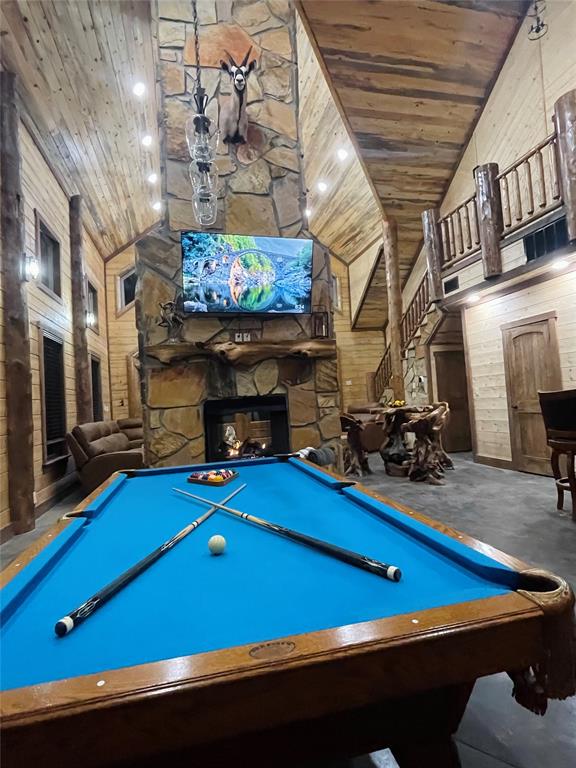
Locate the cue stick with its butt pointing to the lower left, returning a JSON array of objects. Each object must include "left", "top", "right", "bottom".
[{"left": 54, "top": 483, "right": 246, "bottom": 637}]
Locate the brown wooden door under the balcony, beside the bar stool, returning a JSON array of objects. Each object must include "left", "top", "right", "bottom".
[{"left": 502, "top": 314, "right": 562, "bottom": 475}]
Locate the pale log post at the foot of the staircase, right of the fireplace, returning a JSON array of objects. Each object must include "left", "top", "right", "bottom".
[{"left": 382, "top": 219, "right": 404, "bottom": 400}]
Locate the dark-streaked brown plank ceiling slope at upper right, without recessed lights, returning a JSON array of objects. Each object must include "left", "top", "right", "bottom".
[{"left": 299, "top": 0, "right": 527, "bottom": 327}]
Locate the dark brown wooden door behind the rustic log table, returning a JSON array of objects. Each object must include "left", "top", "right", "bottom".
[{"left": 433, "top": 349, "right": 472, "bottom": 453}]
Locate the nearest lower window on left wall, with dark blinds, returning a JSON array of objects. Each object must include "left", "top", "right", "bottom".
[{"left": 40, "top": 331, "right": 67, "bottom": 463}]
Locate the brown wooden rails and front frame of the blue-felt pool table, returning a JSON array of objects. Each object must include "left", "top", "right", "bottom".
[{"left": 0, "top": 468, "right": 573, "bottom": 768}]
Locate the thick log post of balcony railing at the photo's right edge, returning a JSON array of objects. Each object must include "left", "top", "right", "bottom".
[{"left": 554, "top": 89, "right": 576, "bottom": 240}]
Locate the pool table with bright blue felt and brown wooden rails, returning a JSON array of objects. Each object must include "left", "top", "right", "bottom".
[{"left": 1, "top": 457, "right": 574, "bottom": 768}]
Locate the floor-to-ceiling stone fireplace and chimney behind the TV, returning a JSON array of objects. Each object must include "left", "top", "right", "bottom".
[{"left": 136, "top": 0, "right": 340, "bottom": 466}]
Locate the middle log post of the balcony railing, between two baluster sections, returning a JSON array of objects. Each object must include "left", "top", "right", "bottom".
[{"left": 474, "top": 163, "right": 504, "bottom": 278}]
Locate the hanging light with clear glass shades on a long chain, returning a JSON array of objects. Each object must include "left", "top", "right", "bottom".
[{"left": 186, "top": 0, "right": 219, "bottom": 227}]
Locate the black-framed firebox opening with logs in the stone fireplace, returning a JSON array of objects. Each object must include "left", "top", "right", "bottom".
[{"left": 204, "top": 395, "right": 290, "bottom": 461}]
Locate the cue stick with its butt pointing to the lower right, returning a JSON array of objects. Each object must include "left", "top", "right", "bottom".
[{"left": 172, "top": 488, "right": 402, "bottom": 581}]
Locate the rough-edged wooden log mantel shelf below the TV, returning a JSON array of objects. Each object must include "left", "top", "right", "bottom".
[{"left": 144, "top": 339, "right": 336, "bottom": 365}]
